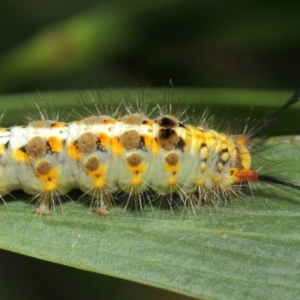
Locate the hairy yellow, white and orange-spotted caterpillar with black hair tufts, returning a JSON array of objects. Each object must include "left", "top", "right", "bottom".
[{"left": 0, "top": 92, "right": 300, "bottom": 216}]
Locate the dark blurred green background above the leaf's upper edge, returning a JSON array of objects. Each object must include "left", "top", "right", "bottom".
[{"left": 0, "top": 0, "right": 300, "bottom": 93}]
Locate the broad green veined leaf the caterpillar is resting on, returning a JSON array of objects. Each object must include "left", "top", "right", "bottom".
[{"left": 0, "top": 90, "right": 300, "bottom": 299}]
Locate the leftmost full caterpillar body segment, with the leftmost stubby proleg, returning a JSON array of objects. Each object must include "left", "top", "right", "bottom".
[{"left": 7, "top": 120, "right": 76, "bottom": 215}]
